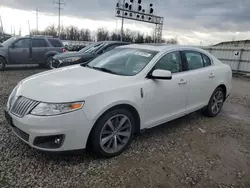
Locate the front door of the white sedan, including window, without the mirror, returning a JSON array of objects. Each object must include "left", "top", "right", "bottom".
[{"left": 143, "top": 51, "right": 189, "bottom": 127}]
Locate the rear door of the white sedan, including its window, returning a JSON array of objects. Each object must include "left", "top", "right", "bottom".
[{"left": 182, "top": 51, "right": 216, "bottom": 113}]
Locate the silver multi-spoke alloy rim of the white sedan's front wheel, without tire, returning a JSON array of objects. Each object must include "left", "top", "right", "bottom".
[{"left": 100, "top": 114, "right": 132, "bottom": 153}]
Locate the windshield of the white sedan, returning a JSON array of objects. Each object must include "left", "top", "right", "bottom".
[{"left": 85, "top": 48, "right": 157, "bottom": 76}]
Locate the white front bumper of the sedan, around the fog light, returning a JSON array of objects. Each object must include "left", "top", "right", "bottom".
[{"left": 5, "top": 110, "right": 93, "bottom": 151}]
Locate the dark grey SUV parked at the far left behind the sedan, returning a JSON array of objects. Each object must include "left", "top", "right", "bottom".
[{"left": 0, "top": 36, "right": 66, "bottom": 70}]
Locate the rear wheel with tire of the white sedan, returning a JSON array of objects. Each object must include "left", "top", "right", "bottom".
[{"left": 204, "top": 87, "right": 225, "bottom": 117}]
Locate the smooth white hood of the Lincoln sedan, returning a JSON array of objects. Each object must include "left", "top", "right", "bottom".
[{"left": 17, "top": 65, "right": 133, "bottom": 103}]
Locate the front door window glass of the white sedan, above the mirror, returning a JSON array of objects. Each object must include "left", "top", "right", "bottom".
[{"left": 154, "top": 52, "right": 182, "bottom": 73}]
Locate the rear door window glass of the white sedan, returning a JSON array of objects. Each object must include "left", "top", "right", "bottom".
[{"left": 185, "top": 52, "right": 204, "bottom": 70}]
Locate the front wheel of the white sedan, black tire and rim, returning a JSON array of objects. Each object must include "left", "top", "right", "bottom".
[{"left": 90, "top": 108, "right": 135, "bottom": 157}]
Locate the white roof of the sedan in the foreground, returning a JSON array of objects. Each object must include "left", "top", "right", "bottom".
[{"left": 118, "top": 44, "right": 206, "bottom": 52}]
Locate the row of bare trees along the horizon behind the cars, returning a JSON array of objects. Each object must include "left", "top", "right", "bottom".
[{"left": 31, "top": 25, "right": 179, "bottom": 44}]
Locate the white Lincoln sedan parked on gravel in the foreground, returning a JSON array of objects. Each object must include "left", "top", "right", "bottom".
[{"left": 6, "top": 45, "right": 232, "bottom": 157}]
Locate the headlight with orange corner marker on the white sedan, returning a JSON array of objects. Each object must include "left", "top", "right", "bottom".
[{"left": 31, "top": 102, "right": 84, "bottom": 116}]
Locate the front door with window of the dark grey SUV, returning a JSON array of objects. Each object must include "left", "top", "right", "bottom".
[{"left": 9, "top": 38, "right": 31, "bottom": 64}]
